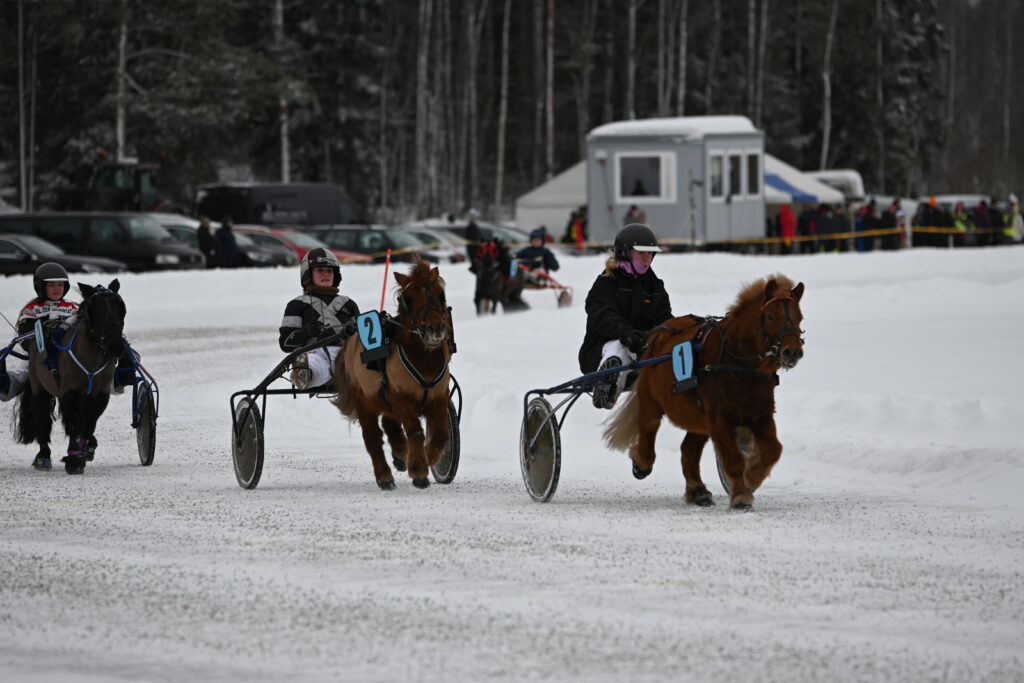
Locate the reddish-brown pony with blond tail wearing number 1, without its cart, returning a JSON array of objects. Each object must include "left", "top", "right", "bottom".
[{"left": 604, "top": 275, "right": 804, "bottom": 508}]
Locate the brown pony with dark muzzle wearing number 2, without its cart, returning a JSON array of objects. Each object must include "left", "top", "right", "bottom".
[{"left": 334, "top": 256, "right": 454, "bottom": 490}]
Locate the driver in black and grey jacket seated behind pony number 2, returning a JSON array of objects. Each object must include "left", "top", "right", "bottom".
[{"left": 279, "top": 247, "right": 359, "bottom": 389}]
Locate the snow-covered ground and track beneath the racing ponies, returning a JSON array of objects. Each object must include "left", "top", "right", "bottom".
[{"left": 0, "top": 248, "right": 1024, "bottom": 682}]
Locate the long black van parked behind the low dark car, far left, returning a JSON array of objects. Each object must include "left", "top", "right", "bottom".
[{"left": 0, "top": 211, "right": 206, "bottom": 270}]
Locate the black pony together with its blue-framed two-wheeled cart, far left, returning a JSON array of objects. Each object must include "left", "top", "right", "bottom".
[{"left": 0, "top": 281, "right": 160, "bottom": 474}]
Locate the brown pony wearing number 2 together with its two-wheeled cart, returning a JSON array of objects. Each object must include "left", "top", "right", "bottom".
[{"left": 230, "top": 262, "right": 462, "bottom": 489}]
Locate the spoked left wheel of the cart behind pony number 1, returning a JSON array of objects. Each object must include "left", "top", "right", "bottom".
[{"left": 519, "top": 396, "right": 562, "bottom": 503}]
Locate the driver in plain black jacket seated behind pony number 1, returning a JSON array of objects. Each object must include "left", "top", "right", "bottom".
[{"left": 580, "top": 223, "right": 673, "bottom": 409}]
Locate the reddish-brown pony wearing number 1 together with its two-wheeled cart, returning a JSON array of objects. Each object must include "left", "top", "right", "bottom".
[{"left": 519, "top": 275, "right": 804, "bottom": 509}]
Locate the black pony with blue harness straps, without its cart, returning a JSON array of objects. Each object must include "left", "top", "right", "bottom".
[{"left": 16, "top": 280, "right": 126, "bottom": 474}]
